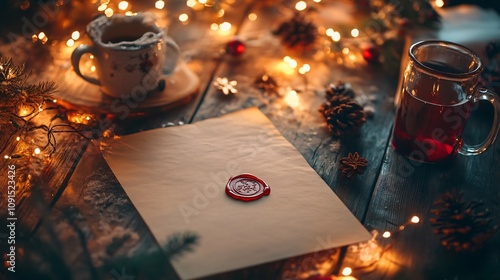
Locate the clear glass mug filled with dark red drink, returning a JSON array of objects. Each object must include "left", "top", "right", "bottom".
[{"left": 391, "top": 41, "right": 500, "bottom": 162}]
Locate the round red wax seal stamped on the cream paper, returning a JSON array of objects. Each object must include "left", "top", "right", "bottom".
[{"left": 226, "top": 173, "right": 271, "bottom": 201}]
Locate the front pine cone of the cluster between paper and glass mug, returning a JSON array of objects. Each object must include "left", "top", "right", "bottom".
[{"left": 323, "top": 102, "right": 366, "bottom": 137}]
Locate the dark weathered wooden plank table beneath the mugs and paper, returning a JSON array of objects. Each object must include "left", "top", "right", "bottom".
[{"left": 0, "top": 1, "right": 500, "bottom": 279}]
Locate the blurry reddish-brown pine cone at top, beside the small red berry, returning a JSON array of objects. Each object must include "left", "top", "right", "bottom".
[{"left": 273, "top": 14, "right": 318, "bottom": 48}]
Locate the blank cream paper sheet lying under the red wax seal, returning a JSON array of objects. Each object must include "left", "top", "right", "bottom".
[{"left": 104, "top": 108, "right": 370, "bottom": 279}]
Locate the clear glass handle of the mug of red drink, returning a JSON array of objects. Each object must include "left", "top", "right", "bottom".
[{"left": 458, "top": 88, "right": 500, "bottom": 156}]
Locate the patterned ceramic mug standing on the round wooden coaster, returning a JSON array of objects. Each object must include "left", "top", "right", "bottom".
[{"left": 71, "top": 13, "right": 179, "bottom": 98}]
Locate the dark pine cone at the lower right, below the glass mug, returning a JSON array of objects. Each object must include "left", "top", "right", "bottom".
[{"left": 430, "top": 190, "right": 498, "bottom": 252}]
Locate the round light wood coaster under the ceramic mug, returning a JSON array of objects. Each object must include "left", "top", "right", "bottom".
[{"left": 55, "top": 61, "right": 200, "bottom": 117}]
